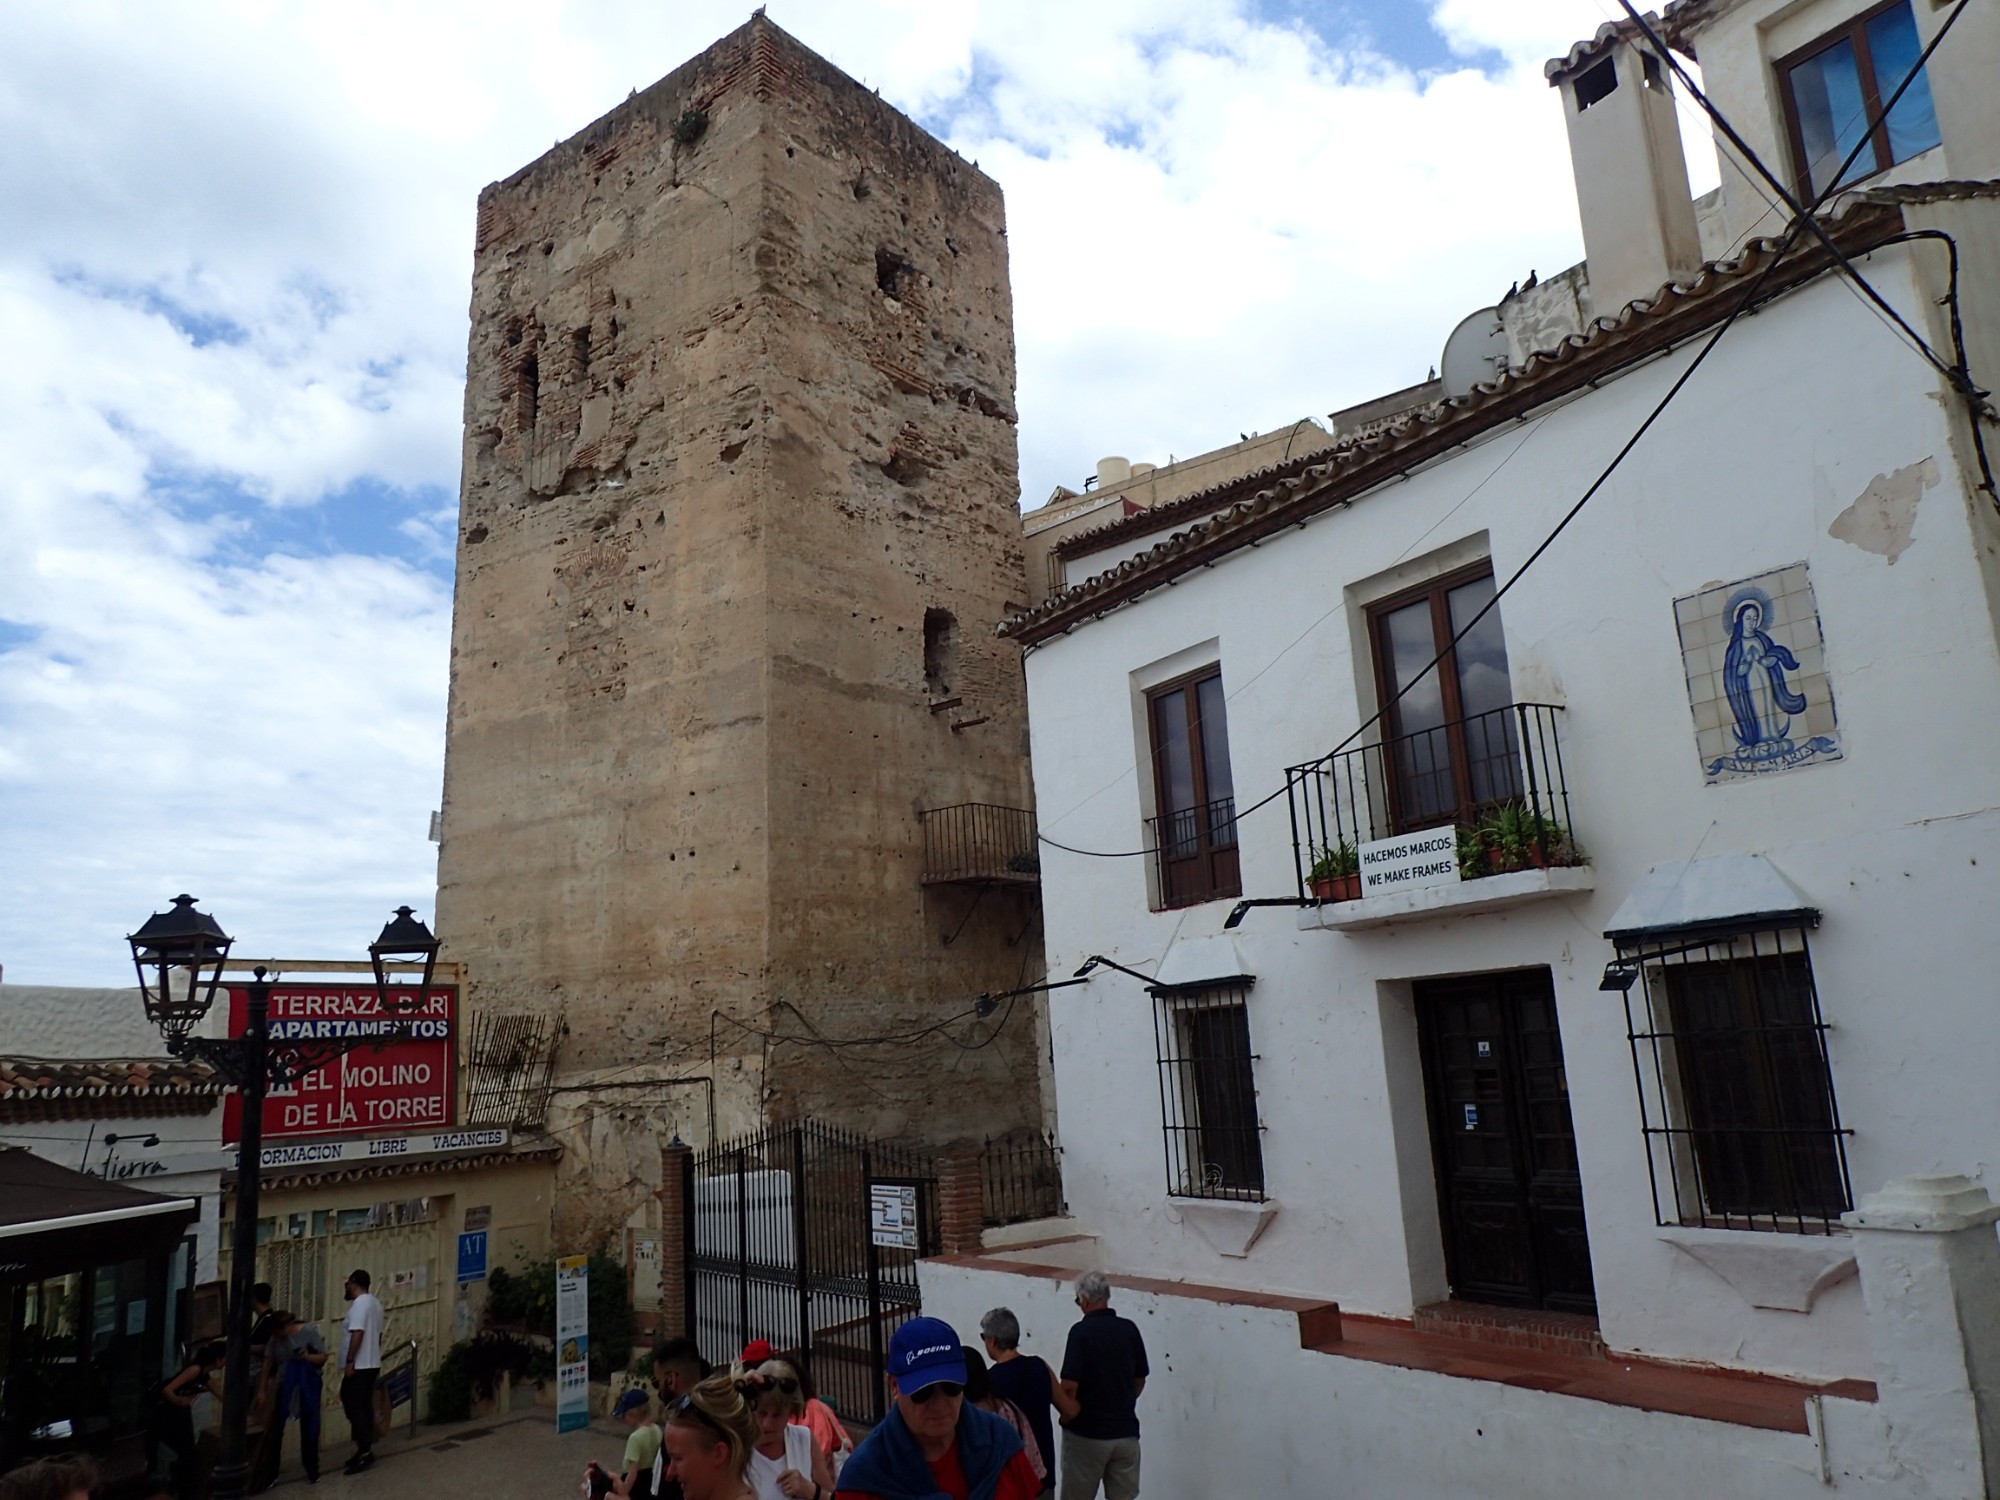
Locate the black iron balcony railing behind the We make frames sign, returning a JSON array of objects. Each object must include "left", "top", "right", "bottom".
[{"left": 1284, "top": 704, "right": 1580, "bottom": 898}]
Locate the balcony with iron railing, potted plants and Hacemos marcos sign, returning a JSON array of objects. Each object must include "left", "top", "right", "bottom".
[{"left": 1286, "top": 704, "right": 1592, "bottom": 928}]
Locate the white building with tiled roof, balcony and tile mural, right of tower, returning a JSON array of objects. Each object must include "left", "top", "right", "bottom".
[{"left": 924, "top": 0, "right": 2000, "bottom": 1496}]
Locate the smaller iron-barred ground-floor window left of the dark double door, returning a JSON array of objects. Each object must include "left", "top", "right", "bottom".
[{"left": 1152, "top": 980, "right": 1264, "bottom": 1200}]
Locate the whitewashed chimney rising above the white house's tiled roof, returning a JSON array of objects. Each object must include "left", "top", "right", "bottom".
[{"left": 1544, "top": 16, "right": 1702, "bottom": 318}]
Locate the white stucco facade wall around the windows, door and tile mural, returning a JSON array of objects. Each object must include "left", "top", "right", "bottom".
[{"left": 1026, "top": 238, "right": 2000, "bottom": 1400}]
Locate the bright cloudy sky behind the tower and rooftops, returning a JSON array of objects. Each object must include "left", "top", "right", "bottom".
[{"left": 0, "top": 0, "right": 1720, "bottom": 982}]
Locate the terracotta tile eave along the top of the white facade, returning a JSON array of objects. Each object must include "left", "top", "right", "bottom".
[{"left": 998, "top": 182, "right": 2000, "bottom": 644}]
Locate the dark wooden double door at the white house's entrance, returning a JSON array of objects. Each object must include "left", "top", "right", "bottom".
[{"left": 1416, "top": 968, "right": 1596, "bottom": 1312}]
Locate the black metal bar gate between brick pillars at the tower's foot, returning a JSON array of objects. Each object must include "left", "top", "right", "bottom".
[{"left": 684, "top": 1120, "right": 938, "bottom": 1422}]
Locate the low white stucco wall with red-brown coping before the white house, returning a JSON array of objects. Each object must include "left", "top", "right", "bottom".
[{"left": 920, "top": 1262, "right": 1886, "bottom": 1500}]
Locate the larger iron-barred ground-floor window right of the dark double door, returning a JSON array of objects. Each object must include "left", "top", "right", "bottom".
[{"left": 1606, "top": 912, "right": 1854, "bottom": 1234}]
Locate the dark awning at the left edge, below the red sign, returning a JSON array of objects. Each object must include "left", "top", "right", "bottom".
[{"left": 0, "top": 1146, "right": 200, "bottom": 1282}]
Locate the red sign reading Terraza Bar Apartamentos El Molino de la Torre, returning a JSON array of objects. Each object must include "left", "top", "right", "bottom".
[{"left": 222, "top": 984, "right": 458, "bottom": 1146}]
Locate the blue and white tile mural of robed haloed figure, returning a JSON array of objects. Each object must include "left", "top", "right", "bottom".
[{"left": 1674, "top": 562, "right": 1840, "bottom": 782}]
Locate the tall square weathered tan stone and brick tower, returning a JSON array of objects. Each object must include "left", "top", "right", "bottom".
[{"left": 438, "top": 12, "right": 1044, "bottom": 1228}]
